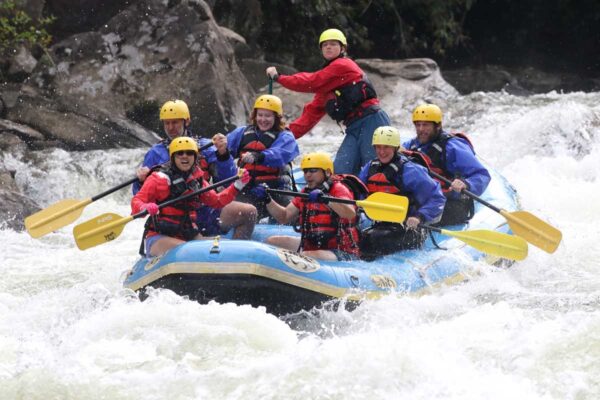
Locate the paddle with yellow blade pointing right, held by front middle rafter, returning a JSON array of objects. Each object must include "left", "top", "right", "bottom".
[{"left": 267, "top": 189, "right": 408, "bottom": 223}]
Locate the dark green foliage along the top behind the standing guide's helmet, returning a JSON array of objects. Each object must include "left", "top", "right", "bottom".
[{"left": 213, "top": 0, "right": 476, "bottom": 69}]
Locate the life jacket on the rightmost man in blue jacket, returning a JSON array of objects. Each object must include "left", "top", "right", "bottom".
[{"left": 402, "top": 131, "right": 475, "bottom": 193}]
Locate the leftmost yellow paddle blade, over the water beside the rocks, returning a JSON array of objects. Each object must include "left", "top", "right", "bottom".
[{"left": 25, "top": 198, "right": 92, "bottom": 238}]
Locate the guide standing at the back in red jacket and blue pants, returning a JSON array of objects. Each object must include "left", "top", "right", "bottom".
[{"left": 266, "top": 29, "right": 390, "bottom": 174}]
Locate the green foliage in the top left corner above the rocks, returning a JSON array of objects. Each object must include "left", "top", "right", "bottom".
[{"left": 0, "top": 0, "right": 55, "bottom": 54}]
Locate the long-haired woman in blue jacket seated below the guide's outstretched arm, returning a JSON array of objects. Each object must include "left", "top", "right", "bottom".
[{"left": 226, "top": 94, "right": 300, "bottom": 220}]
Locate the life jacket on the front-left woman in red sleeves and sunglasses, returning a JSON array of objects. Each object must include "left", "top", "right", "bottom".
[{"left": 145, "top": 166, "right": 204, "bottom": 240}]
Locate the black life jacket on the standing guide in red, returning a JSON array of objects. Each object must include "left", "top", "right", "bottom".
[{"left": 325, "top": 75, "right": 379, "bottom": 125}]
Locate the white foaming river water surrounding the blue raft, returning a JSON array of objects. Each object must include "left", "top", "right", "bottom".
[{"left": 0, "top": 89, "right": 600, "bottom": 400}]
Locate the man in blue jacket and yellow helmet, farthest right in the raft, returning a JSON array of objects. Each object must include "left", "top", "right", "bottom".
[{"left": 404, "top": 104, "right": 491, "bottom": 225}]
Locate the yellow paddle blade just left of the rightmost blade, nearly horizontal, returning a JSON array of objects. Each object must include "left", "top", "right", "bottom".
[{"left": 441, "top": 229, "right": 528, "bottom": 260}]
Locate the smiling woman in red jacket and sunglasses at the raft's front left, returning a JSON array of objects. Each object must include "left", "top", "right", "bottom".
[{"left": 131, "top": 137, "right": 256, "bottom": 256}]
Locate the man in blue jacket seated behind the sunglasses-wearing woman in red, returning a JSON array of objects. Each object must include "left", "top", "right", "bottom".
[{"left": 132, "top": 100, "right": 256, "bottom": 239}]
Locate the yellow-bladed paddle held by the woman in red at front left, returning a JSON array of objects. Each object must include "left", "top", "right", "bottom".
[{"left": 73, "top": 175, "right": 239, "bottom": 250}]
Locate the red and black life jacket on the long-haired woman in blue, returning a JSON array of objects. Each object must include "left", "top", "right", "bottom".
[{"left": 238, "top": 125, "right": 281, "bottom": 183}]
